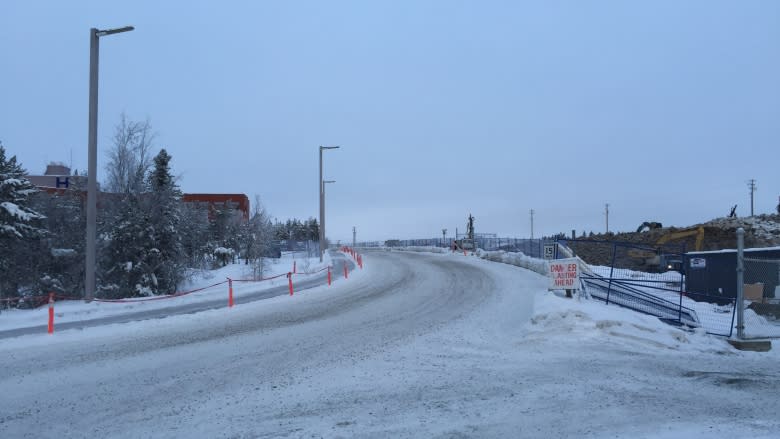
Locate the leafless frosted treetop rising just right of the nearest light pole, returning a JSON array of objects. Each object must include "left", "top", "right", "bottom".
[{"left": 106, "top": 113, "right": 155, "bottom": 194}]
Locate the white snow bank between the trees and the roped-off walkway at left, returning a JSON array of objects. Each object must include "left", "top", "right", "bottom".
[{"left": 0, "top": 253, "right": 332, "bottom": 331}]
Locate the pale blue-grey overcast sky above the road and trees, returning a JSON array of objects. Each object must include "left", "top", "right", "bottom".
[{"left": 0, "top": 0, "right": 780, "bottom": 240}]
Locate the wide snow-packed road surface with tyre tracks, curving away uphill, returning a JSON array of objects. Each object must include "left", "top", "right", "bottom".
[{"left": 0, "top": 253, "right": 780, "bottom": 438}]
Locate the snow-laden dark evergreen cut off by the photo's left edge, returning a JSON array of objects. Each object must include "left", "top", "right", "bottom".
[{"left": 0, "top": 143, "right": 44, "bottom": 295}]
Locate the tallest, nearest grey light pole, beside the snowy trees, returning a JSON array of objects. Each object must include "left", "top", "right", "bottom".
[{"left": 84, "top": 26, "right": 135, "bottom": 301}]
